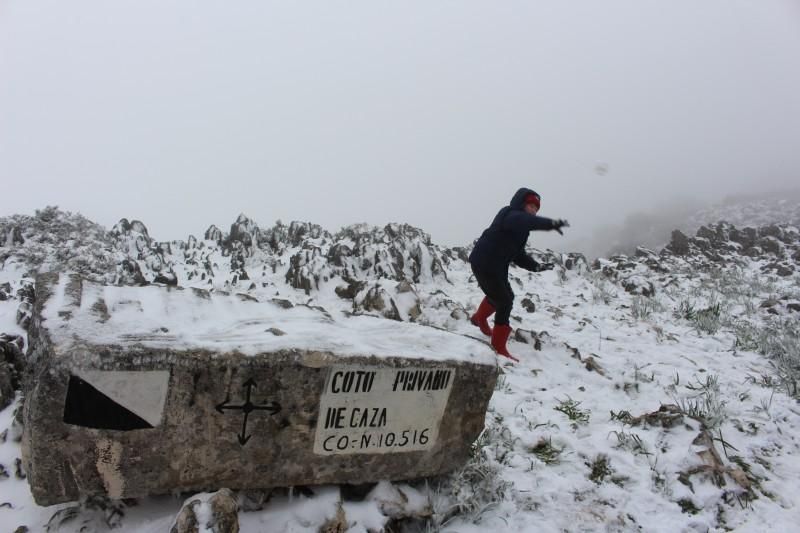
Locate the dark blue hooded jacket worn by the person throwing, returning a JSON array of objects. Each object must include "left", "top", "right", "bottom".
[{"left": 469, "top": 187, "right": 554, "bottom": 276}]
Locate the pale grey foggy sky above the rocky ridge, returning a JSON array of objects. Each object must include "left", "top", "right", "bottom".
[{"left": 0, "top": 0, "right": 800, "bottom": 249}]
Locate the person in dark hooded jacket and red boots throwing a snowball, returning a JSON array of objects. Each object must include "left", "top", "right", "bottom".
[{"left": 469, "top": 187, "right": 569, "bottom": 361}]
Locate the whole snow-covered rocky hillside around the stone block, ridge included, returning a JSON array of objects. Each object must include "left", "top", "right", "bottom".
[{"left": 0, "top": 208, "right": 800, "bottom": 532}]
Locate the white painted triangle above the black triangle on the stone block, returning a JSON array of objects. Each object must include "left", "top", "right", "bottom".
[{"left": 76, "top": 370, "right": 169, "bottom": 427}]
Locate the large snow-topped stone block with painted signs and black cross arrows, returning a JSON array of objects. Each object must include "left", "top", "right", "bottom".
[{"left": 23, "top": 274, "right": 498, "bottom": 505}]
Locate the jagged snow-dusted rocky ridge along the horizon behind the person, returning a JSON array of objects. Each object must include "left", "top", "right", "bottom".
[{"left": 0, "top": 207, "right": 800, "bottom": 325}]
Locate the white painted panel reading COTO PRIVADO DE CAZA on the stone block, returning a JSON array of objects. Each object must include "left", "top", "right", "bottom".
[{"left": 314, "top": 366, "right": 456, "bottom": 455}]
